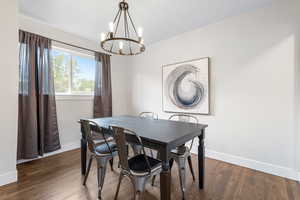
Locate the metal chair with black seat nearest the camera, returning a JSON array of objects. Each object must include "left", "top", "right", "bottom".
[{"left": 112, "top": 127, "right": 162, "bottom": 200}]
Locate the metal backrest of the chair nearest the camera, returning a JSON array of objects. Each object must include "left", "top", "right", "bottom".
[{"left": 111, "top": 126, "right": 151, "bottom": 173}]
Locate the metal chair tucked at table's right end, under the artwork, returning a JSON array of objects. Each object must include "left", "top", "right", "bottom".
[{"left": 152, "top": 114, "right": 199, "bottom": 199}]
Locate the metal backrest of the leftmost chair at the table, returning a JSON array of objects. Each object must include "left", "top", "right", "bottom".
[{"left": 80, "top": 119, "right": 113, "bottom": 155}]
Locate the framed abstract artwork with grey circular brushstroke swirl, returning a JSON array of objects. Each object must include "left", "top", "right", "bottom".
[{"left": 162, "top": 57, "right": 210, "bottom": 115}]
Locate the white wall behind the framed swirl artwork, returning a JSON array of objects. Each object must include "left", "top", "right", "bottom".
[{"left": 120, "top": 0, "right": 300, "bottom": 178}]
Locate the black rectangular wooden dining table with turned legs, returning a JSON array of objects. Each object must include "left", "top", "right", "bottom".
[{"left": 81, "top": 115, "right": 208, "bottom": 200}]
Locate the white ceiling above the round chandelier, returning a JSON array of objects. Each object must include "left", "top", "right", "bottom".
[{"left": 19, "top": 0, "right": 272, "bottom": 44}]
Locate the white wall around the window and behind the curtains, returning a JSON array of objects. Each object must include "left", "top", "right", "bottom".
[{"left": 19, "top": 15, "right": 128, "bottom": 155}]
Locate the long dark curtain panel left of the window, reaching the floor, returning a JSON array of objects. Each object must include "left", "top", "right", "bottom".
[{"left": 18, "top": 31, "right": 60, "bottom": 159}]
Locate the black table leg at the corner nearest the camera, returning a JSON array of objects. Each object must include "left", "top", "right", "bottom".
[{"left": 160, "top": 147, "right": 171, "bottom": 200}]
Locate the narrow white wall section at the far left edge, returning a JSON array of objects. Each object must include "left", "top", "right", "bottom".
[{"left": 0, "top": 0, "right": 19, "bottom": 186}]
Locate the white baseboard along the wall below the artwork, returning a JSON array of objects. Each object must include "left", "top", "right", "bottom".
[{"left": 192, "top": 148, "right": 300, "bottom": 181}]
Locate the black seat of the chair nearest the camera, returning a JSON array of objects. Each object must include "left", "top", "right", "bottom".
[{"left": 128, "top": 154, "right": 161, "bottom": 176}]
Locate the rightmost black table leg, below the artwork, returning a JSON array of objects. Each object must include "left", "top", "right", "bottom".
[{"left": 198, "top": 130, "right": 205, "bottom": 189}]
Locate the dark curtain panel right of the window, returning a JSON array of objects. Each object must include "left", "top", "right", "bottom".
[{"left": 94, "top": 53, "right": 112, "bottom": 118}]
